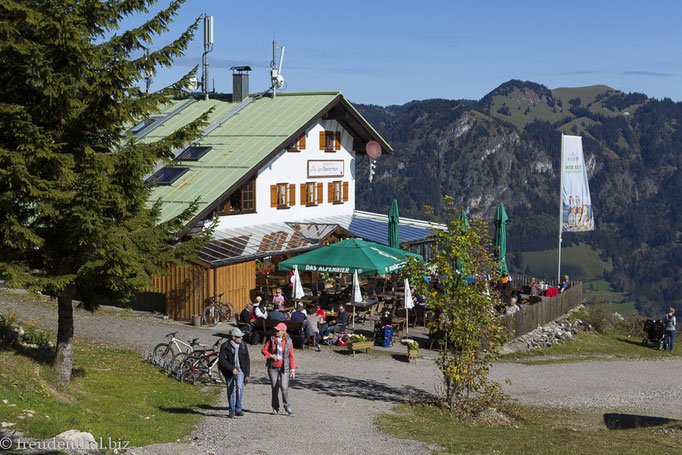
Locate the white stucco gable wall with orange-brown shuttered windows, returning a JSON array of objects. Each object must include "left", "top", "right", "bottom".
[{"left": 218, "top": 120, "right": 355, "bottom": 229}]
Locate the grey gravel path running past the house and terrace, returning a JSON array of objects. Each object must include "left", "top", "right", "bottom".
[{"left": 0, "top": 292, "right": 682, "bottom": 455}]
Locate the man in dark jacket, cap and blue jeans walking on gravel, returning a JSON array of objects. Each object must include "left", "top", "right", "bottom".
[{"left": 218, "top": 329, "right": 251, "bottom": 418}]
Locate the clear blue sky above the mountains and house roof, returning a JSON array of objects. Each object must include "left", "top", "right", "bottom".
[{"left": 127, "top": 0, "right": 682, "bottom": 105}]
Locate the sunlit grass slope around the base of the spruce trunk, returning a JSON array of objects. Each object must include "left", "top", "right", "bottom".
[{"left": 0, "top": 341, "right": 220, "bottom": 446}]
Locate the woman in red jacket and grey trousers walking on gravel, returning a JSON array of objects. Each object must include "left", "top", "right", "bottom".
[{"left": 261, "top": 322, "right": 297, "bottom": 415}]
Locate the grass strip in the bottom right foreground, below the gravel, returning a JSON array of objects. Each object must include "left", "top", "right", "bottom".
[{"left": 377, "top": 405, "right": 682, "bottom": 455}]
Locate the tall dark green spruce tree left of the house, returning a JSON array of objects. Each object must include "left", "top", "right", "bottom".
[{"left": 0, "top": 0, "right": 211, "bottom": 386}]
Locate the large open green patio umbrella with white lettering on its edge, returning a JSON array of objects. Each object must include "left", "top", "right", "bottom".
[{"left": 277, "top": 239, "right": 423, "bottom": 275}]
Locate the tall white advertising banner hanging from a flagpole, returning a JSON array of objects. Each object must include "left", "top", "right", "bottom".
[{"left": 561, "top": 135, "right": 594, "bottom": 232}]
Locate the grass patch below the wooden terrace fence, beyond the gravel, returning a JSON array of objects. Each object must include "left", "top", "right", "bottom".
[{"left": 502, "top": 329, "right": 681, "bottom": 364}]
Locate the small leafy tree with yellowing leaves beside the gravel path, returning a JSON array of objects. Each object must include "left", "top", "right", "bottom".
[{"left": 404, "top": 197, "right": 506, "bottom": 414}]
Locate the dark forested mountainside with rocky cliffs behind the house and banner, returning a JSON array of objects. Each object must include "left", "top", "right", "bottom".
[{"left": 356, "top": 81, "right": 682, "bottom": 314}]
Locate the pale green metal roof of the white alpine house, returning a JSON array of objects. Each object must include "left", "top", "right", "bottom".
[{"left": 142, "top": 92, "right": 390, "bottom": 226}]
